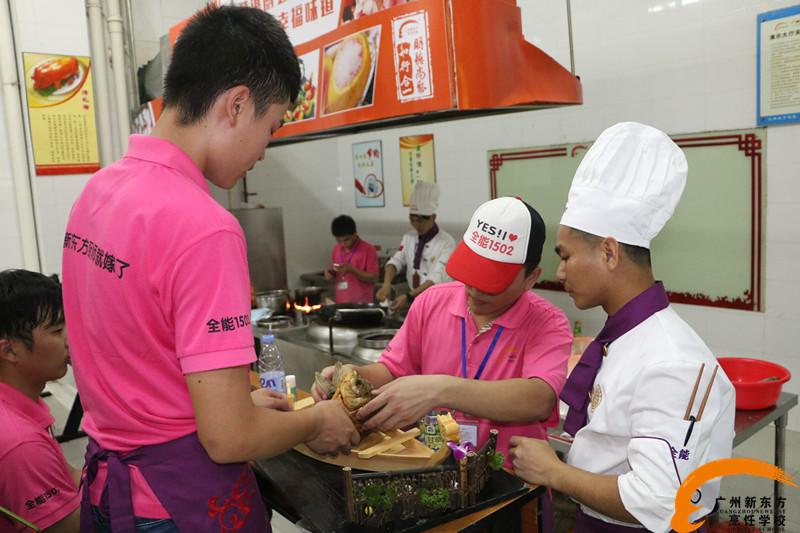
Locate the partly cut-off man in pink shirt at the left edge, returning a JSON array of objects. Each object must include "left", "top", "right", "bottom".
[{"left": 0, "top": 270, "right": 80, "bottom": 533}]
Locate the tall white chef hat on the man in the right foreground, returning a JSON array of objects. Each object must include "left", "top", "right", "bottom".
[{"left": 561, "top": 122, "right": 689, "bottom": 248}]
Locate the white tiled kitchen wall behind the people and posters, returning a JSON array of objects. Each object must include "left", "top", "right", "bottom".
[{"left": 0, "top": 0, "right": 800, "bottom": 429}]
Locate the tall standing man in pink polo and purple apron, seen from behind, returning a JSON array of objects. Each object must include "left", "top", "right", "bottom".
[{"left": 63, "top": 5, "right": 359, "bottom": 533}]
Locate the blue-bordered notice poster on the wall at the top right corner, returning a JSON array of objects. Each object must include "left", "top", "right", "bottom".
[{"left": 756, "top": 6, "right": 800, "bottom": 126}]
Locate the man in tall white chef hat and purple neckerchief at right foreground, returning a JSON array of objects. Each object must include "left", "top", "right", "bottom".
[{"left": 510, "top": 122, "right": 735, "bottom": 533}]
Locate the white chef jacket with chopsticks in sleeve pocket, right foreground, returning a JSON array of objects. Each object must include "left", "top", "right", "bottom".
[{"left": 567, "top": 307, "right": 735, "bottom": 533}]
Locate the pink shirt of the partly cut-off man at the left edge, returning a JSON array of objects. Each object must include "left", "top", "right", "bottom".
[{"left": 0, "top": 382, "right": 80, "bottom": 533}]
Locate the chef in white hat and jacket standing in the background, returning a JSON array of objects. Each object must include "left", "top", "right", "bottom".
[{"left": 375, "top": 181, "right": 456, "bottom": 309}]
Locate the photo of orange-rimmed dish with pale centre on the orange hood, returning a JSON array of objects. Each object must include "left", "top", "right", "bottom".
[{"left": 322, "top": 26, "right": 381, "bottom": 115}]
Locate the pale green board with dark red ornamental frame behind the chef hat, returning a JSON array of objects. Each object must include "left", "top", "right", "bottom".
[{"left": 488, "top": 128, "right": 767, "bottom": 311}]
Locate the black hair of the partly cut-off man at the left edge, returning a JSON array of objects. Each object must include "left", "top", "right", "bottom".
[{"left": 0, "top": 269, "right": 64, "bottom": 350}]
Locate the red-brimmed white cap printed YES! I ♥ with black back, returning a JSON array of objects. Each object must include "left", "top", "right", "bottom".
[{"left": 447, "top": 196, "right": 545, "bottom": 294}]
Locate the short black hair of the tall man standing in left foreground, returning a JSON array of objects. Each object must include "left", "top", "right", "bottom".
[{"left": 163, "top": 5, "right": 301, "bottom": 126}]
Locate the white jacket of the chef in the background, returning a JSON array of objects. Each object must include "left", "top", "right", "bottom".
[{"left": 386, "top": 228, "right": 456, "bottom": 289}]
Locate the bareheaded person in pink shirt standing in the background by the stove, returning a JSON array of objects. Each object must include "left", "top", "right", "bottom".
[{"left": 325, "top": 215, "right": 380, "bottom": 304}]
